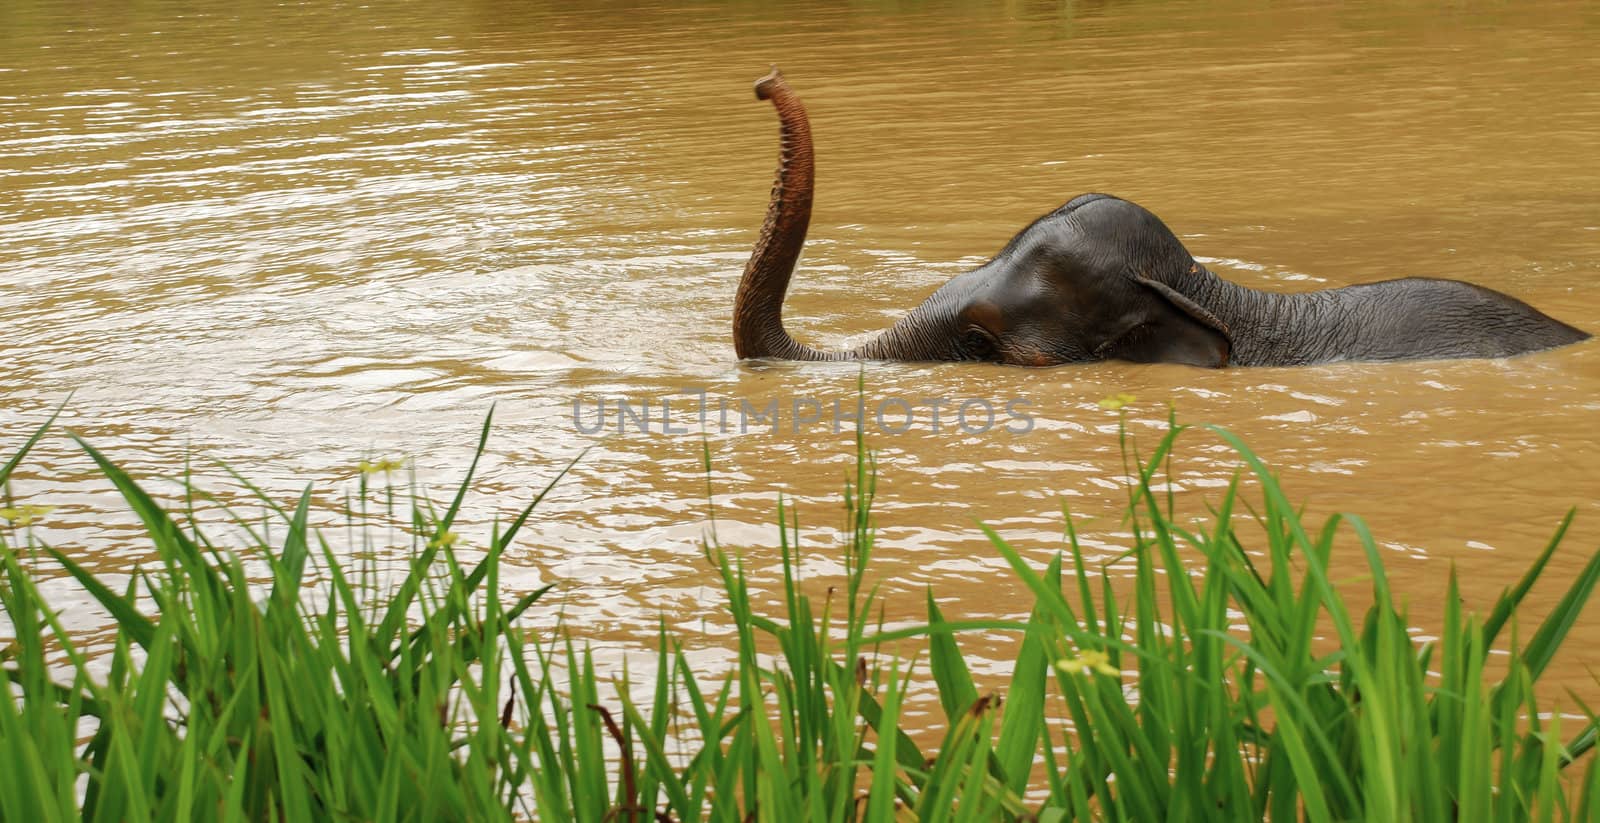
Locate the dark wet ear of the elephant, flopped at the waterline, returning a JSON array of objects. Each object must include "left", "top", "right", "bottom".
[{"left": 1099, "top": 274, "right": 1234, "bottom": 368}]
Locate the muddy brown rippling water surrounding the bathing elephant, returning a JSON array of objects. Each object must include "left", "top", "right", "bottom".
[{"left": 0, "top": 0, "right": 1600, "bottom": 703}]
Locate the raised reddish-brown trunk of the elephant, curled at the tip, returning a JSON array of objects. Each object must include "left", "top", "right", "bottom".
[{"left": 733, "top": 67, "right": 843, "bottom": 360}]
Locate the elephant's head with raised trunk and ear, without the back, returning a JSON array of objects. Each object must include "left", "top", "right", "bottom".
[{"left": 733, "top": 69, "right": 1232, "bottom": 367}]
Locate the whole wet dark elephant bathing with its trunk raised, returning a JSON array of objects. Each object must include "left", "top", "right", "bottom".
[{"left": 733, "top": 67, "right": 1589, "bottom": 368}]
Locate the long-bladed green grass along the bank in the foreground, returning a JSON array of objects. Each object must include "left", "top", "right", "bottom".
[{"left": 0, "top": 400, "right": 1600, "bottom": 823}]
